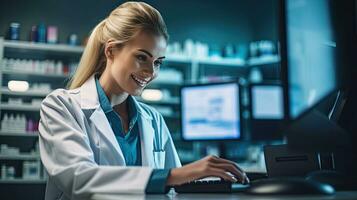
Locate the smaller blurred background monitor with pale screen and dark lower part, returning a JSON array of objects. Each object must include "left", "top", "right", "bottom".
[{"left": 246, "top": 82, "right": 284, "bottom": 142}]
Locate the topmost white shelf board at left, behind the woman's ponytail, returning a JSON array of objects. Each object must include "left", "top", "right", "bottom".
[{"left": 4, "top": 40, "right": 84, "bottom": 54}]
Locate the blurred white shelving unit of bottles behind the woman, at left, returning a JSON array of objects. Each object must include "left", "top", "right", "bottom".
[{"left": 0, "top": 38, "right": 84, "bottom": 184}]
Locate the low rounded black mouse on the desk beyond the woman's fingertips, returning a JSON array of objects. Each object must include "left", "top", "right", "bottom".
[{"left": 245, "top": 177, "right": 335, "bottom": 195}]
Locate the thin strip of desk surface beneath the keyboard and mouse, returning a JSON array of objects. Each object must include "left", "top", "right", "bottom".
[{"left": 91, "top": 191, "right": 357, "bottom": 200}]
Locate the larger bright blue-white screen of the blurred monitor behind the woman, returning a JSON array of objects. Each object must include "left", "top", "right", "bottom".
[{"left": 181, "top": 83, "right": 241, "bottom": 140}]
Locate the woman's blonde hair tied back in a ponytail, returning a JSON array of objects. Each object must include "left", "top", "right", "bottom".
[{"left": 67, "top": 2, "right": 168, "bottom": 89}]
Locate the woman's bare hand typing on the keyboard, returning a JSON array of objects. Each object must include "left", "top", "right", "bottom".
[{"left": 166, "top": 156, "right": 249, "bottom": 186}]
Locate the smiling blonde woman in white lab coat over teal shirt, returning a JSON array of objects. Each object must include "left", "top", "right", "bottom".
[{"left": 39, "top": 2, "right": 246, "bottom": 199}]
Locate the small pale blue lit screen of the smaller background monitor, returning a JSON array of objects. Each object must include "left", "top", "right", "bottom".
[{"left": 251, "top": 85, "right": 284, "bottom": 120}]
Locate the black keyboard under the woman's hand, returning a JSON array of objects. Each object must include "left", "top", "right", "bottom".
[{"left": 174, "top": 177, "right": 232, "bottom": 193}]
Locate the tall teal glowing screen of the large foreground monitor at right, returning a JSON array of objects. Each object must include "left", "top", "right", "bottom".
[{"left": 285, "top": 0, "right": 337, "bottom": 119}]
